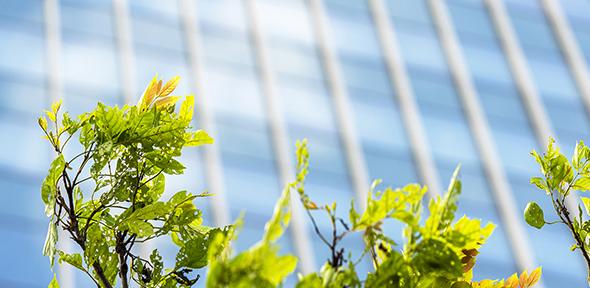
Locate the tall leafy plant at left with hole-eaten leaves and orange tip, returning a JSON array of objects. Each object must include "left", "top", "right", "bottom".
[{"left": 39, "top": 77, "right": 224, "bottom": 288}]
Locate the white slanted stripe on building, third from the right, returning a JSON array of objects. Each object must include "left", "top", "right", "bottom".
[{"left": 428, "top": 0, "right": 536, "bottom": 276}]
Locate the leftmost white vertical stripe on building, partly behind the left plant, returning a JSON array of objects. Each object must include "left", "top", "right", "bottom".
[{"left": 44, "top": 0, "right": 76, "bottom": 288}]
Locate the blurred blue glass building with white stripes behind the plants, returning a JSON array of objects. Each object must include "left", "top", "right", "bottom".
[{"left": 0, "top": 0, "right": 590, "bottom": 287}]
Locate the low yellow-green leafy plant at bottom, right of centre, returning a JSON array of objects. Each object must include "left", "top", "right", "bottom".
[{"left": 297, "top": 141, "right": 541, "bottom": 288}]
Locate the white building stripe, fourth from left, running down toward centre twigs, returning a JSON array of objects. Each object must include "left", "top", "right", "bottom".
[{"left": 245, "top": 0, "right": 315, "bottom": 274}]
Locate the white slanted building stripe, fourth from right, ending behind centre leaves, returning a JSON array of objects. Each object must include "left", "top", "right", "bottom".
[{"left": 369, "top": 0, "right": 441, "bottom": 197}]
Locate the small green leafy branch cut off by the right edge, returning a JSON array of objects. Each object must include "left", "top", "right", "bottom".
[{"left": 524, "top": 139, "right": 590, "bottom": 283}]
